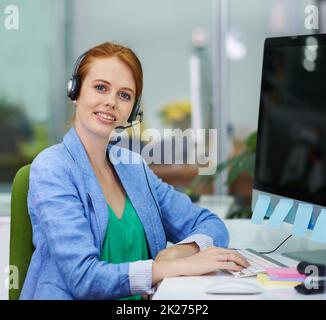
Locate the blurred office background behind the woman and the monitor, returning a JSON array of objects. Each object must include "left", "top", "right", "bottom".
[{"left": 0, "top": 0, "right": 326, "bottom": 299}]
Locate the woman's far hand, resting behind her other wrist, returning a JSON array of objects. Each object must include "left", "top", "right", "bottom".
[{"left": 155, "top": 242, "right": 199, "bottom": 261}]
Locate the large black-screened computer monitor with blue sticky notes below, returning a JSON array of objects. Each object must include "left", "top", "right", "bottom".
[{"left": 252, "top": 34, "right": 326, "bottom": 264}]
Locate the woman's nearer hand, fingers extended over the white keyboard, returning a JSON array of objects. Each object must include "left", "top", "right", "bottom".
[{"left": 152, "top": 247, "right": 249, "bottom": 285}]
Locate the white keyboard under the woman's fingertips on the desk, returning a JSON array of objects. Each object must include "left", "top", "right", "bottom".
[{"left": 225, "top": 249, "right": 287, "bottom": 278}]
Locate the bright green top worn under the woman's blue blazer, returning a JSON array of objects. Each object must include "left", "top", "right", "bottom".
[{"left": 101, "top": 196, "right": 148, "bottom": 300}]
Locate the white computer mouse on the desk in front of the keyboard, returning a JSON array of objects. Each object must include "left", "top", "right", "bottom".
[{"left": 205, "top": 280, "right": 263, "bottom": 295}]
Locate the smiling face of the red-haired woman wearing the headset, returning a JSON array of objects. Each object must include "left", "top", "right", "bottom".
[{"left": 75, "top": 57, "right": 136, "bottom": 138}]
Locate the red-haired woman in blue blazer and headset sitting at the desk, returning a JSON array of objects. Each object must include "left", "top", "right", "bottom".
[{"left": 20, "top": 43, "right": 248, "bottom": 299}]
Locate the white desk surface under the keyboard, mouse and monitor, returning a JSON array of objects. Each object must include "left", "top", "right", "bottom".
[{"left": 152, "top": 219, "right": 326, "bottom": 300}]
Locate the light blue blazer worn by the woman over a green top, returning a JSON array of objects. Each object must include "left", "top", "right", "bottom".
[{"left": 20, "top": 128, "right": 229, "bottom": 299}]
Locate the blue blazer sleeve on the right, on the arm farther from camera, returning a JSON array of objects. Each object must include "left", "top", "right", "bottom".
[{"left": 143, "top": 160, "right": 229, "bottom": 247}]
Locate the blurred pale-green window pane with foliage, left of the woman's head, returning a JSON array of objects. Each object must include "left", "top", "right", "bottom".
[{"left": 0, "top": 0, "right": 65, "bottom": 191}]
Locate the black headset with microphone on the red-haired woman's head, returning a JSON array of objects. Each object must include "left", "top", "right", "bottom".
[{"left": 67, "top": 50, "right": 143, "bottom": 124}]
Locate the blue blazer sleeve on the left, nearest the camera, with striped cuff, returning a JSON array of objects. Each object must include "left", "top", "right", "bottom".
[{"left": 28, "top": 160, "right": 151, "bottom": 299}]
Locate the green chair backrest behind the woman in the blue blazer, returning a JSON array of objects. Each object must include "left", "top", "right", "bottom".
[{"left": 9, "top": 164, "right": 34, "bottom": 300}]
